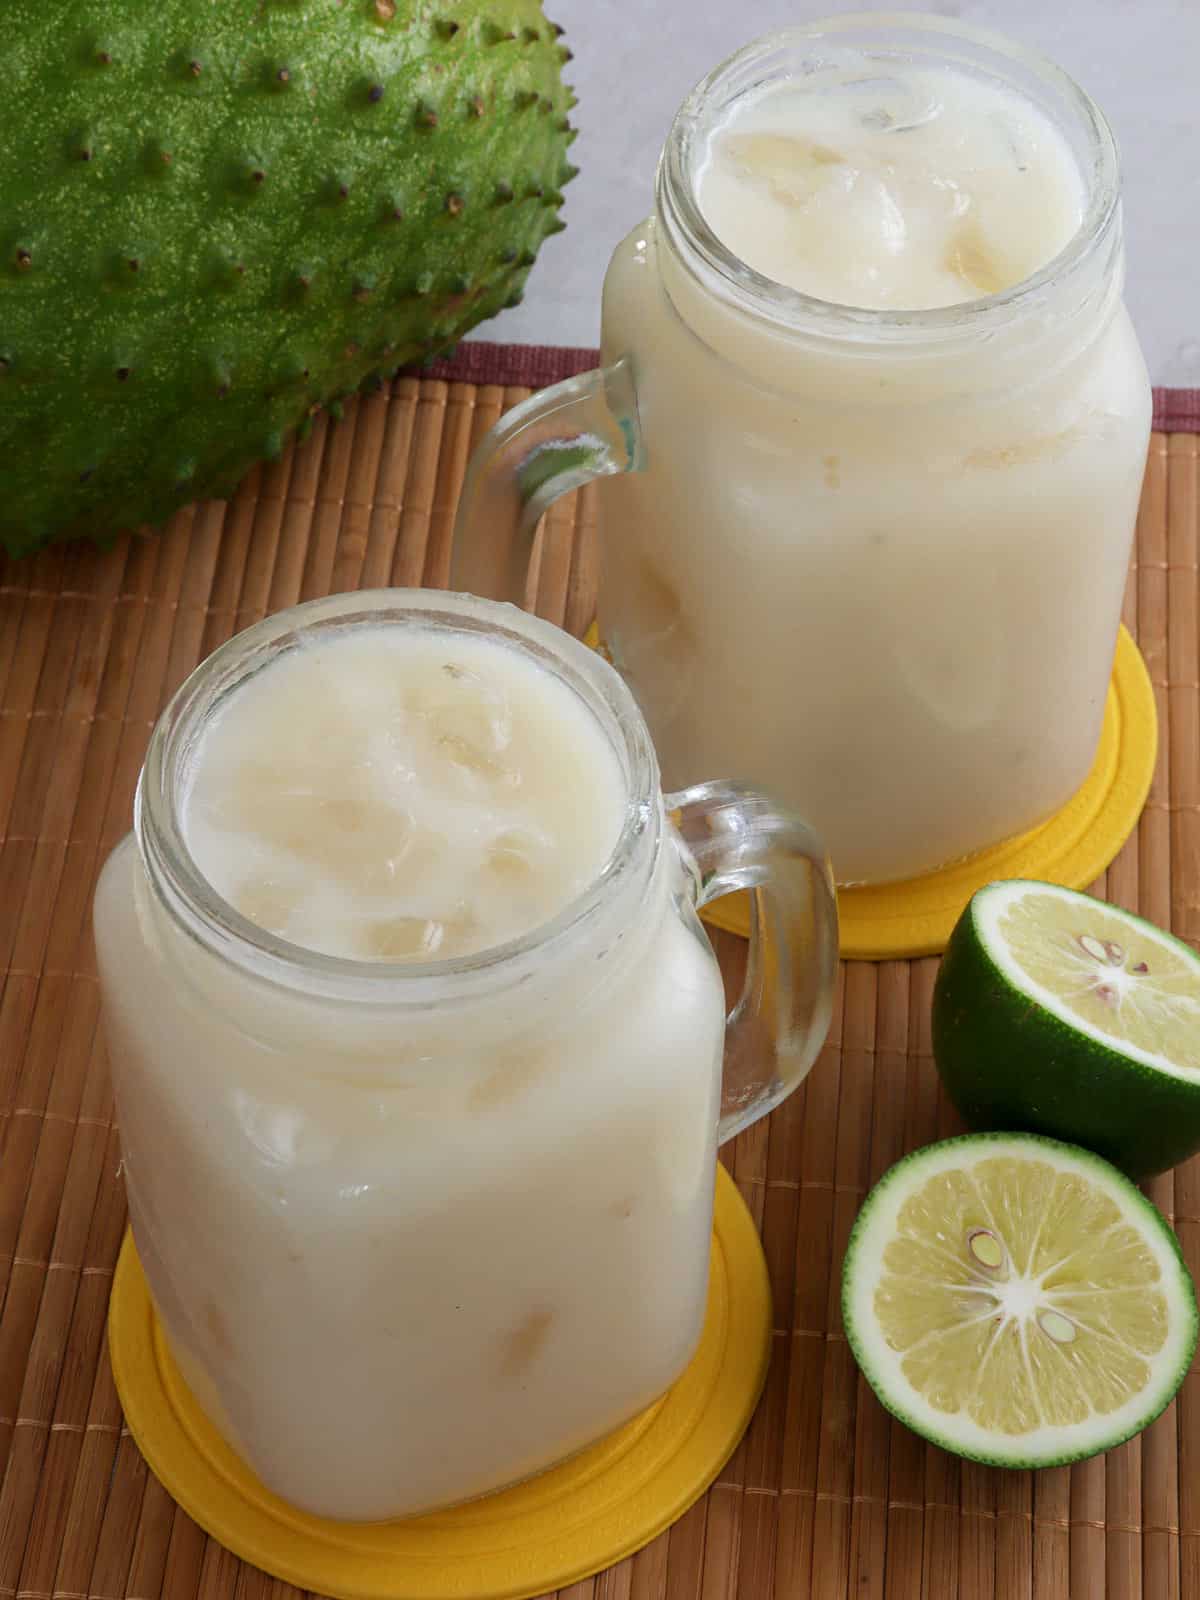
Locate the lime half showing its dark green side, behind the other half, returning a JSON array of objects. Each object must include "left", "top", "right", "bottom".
[{"left": 933, "top": 878, "right": 1200, "bottom": 1178}]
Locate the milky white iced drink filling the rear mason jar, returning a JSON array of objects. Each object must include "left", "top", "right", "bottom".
[{"left": 598, "top": 31, "right": 1150, "bottom": 882}]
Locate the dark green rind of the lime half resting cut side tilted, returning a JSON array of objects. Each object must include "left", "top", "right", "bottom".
[{"left": 933, "top": 878, "right": 1200, "bottom": 1178}]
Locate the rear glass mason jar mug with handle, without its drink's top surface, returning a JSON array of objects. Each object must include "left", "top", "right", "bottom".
[{"left": 453, "top": 14, "right": 1150, "bottom": 883}]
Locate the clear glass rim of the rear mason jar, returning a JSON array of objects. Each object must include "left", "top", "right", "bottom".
[{"left": 656, "top": 11, "right": 1120, "bottom": 344}]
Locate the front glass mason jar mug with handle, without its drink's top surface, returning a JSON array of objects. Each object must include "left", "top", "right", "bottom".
[{"left": 94, "top": 590, "right": 837, "bottom": 1520}]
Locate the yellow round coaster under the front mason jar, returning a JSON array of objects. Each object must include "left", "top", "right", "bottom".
[{"left": 109, "top": 1168, "right": 771, "bottom": 1600}]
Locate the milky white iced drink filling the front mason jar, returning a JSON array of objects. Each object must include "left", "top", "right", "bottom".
[{"left": 96, "top": 601, "right": 725, "bottom": 1518}]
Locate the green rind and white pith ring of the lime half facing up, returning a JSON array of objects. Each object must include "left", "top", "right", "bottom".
[{"left": 842, "top": 1133, "right": 1200, "bottom": 1470}]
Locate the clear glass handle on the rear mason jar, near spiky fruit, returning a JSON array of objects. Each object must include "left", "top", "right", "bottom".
[{"left": 450, "top": 355, "right": 642, "bottom": 605}]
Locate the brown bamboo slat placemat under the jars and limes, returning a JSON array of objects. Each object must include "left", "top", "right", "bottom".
[{"left": 0, "top": 352, "right": 1200, "bottom": 1600}]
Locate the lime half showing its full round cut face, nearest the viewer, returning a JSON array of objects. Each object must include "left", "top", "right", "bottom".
[{"left": 842, "top": 1133, "right": 1197, "bottom": 1467}]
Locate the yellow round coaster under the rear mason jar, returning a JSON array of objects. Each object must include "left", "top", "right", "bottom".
[{"left": 589, "top": 627, "right": 1158, "bottom": 962}]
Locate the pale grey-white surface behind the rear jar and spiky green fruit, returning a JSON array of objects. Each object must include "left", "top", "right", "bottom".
[{"left": 489, "top": 0, "right": 1200, "bottom": 386}]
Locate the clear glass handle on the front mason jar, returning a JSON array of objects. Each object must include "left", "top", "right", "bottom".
[{"left": 666, "top": 782, "right": 837, "bottom": 1142}]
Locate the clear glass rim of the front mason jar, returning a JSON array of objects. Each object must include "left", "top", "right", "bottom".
[{"left": 133, "top": 589, "right": 662, "bottom": 1005}]
